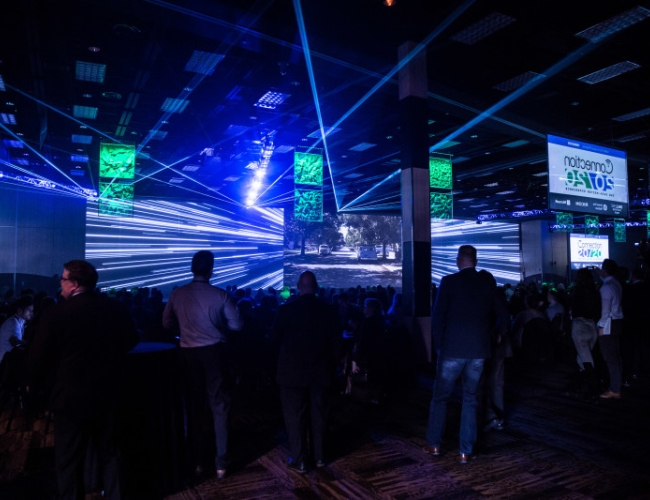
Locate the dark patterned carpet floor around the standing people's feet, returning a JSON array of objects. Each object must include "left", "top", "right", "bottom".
[{"left": 0, "top": 366, "right": 650, "bottom": 500}]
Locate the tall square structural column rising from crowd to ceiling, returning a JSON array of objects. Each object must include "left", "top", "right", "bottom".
[{"left": 398, "top": 42, "right": 431, "bottom": 361}]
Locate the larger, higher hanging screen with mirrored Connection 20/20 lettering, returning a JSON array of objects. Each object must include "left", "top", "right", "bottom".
[{"left": 548, "top": 135, "right": 628, "bottom": 217}]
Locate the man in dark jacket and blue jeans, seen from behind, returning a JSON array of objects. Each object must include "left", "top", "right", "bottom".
[{"left": 424, "top": 245, "right": 496, "bottom": 463}]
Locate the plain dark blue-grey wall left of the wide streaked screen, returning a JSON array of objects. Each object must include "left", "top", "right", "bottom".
[{"left": 0, "top": 186, "right": 86, "bottom": 293}]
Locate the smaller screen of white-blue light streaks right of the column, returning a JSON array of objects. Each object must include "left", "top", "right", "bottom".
[{"left": 431, "top": 220, "right": 522, "bottom": 285}]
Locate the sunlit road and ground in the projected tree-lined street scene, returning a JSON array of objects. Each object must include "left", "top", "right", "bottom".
[{"left": 284, "top": 247, "right": 402, "bottom": 290}]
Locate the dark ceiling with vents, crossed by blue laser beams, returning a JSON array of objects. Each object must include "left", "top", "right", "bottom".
[{"left": 0, "top": 0, "right": 650, "bottom": 219}]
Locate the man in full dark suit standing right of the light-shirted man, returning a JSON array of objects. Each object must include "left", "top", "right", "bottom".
[{"left": 273, "top": 271, "right": 341, "bottom": 474}]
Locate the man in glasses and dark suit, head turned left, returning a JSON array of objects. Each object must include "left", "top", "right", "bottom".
[{"left": 28, "top": 260, "right": 138, "bottom": 500}]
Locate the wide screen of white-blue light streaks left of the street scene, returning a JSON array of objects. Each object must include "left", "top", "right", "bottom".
[{"left": 86, "top": 199, "right": 284, "bottom": 298}]
